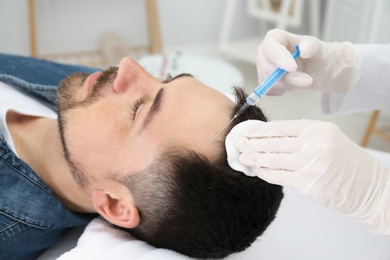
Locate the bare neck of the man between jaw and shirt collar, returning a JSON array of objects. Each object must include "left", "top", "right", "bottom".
[{"left": 7, "top": 112, "right": 96, "bottom": 213}]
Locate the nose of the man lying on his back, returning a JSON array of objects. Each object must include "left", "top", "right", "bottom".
[{"left": 113, "top": 57, "right": 150, "bottom": 93}]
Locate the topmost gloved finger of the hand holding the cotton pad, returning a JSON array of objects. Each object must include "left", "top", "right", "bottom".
[{"left": 239, "top": 119, "right": 317, "bottom": 138}]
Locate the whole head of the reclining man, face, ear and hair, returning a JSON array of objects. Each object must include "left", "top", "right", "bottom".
[{"left": 58, "top": 58, "right": 283, "bottom": 257}]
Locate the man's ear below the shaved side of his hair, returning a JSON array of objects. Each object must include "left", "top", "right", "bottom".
[{"left": 92, "top": 190, "right": 140, "bottom": 228}]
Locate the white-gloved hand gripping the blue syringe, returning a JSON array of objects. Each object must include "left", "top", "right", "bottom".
[{"left": 257, "top": 29, "right": 362, "bottom": 95}]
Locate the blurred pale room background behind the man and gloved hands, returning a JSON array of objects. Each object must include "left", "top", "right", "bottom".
[{"left": 0, "top": 0, "right": 390, "bottom": 152}]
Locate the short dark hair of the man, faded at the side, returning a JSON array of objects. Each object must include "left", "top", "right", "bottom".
[{"left": 119, "top": 88, "right": 283, "bottom": 258}]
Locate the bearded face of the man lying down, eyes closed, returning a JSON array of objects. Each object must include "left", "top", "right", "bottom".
[{"left": 58, "top": 58, "right": 234, "bottom": 184}]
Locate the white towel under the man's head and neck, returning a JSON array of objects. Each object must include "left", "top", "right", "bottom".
[{"left": 58, "top": 218, "right": 190, "bottom": 260}]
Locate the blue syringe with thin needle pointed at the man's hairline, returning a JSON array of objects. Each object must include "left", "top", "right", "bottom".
[{"left": 209, "top": 45, "right": 300, "bottom": 143}]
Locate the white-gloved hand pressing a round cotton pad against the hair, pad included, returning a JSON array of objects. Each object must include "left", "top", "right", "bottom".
[{"left": 225, "top": 120, "right": 390, "bottom": 235}]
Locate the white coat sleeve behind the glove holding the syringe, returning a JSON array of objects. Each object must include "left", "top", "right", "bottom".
[{"left": 321, "top": 44, "right": 390, "bottom": 114}]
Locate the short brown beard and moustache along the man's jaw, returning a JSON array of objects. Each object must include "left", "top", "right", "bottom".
[{"left": 56, "top": 67, "right": 118, "bottom": 188}]
